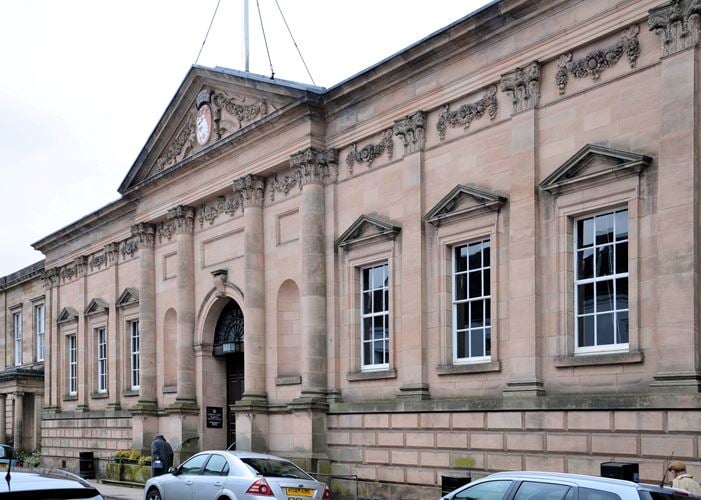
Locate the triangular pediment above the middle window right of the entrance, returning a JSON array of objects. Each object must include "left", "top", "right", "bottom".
[{"left": 425, "top": 184, "right": 506, "bottom": 225}]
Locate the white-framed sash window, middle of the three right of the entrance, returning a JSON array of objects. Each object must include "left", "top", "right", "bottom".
[{"left": 453, "top": 239, "right": 492, "bottom": 363}]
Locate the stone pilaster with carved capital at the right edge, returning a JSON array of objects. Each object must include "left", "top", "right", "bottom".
[{"left": 648, "top": 0, "right": 701, "bottom": 393}]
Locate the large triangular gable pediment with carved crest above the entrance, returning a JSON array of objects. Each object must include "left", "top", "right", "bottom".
[{"left": 119, "top": 66, "right": 322, "bottom": 194}]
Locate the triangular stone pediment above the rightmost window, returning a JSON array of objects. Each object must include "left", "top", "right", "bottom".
[{"left": 540, "top": 144, "right": 652, "bottom": 193}]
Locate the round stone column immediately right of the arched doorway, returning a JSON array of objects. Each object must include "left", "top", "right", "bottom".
[{"left": 234, "top": 175, "right": 267, "bottom": 402}]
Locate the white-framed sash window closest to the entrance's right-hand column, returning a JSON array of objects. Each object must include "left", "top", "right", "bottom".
[{"left": 360, "top": 263, "right": 389, "bottom": 370}]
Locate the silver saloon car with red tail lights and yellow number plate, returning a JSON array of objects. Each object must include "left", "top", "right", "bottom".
[{"left": 144, "top": 450, "right": 330, "bottom": 500}]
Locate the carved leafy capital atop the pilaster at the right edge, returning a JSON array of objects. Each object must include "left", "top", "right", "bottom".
[{"left": 647, "top": 0, "right": 701, "bottom": 56}]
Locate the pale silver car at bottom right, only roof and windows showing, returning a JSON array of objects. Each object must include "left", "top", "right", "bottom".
[{"left": 442, "top": 471, "right": 701, "bottom": 500}]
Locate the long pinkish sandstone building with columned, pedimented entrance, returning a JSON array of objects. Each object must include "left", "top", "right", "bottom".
[{"left": 0, "top": 0, "right": 701, "bottom": 498}]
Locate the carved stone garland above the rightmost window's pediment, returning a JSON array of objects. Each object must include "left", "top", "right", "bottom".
[{"left": 555, "top": 24, "right": 640, "bottom": 95}]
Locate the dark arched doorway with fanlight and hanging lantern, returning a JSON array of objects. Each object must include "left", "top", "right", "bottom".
[{"left": 212, "top": 300, "right": 244, "bottom": 449}]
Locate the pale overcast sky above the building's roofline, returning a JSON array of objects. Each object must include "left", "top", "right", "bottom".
[{"left": 0, "top": 0, "right": 489, "bottom": 276}]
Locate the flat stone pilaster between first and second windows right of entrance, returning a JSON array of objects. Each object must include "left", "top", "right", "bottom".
[{"left": 390, "top": 111, "right": 430, "bottom": 399}]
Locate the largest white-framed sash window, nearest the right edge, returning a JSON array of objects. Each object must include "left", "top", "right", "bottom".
[{"left": 574, "top": 210, "right": 628, "bottom": 353}]
